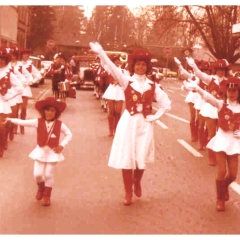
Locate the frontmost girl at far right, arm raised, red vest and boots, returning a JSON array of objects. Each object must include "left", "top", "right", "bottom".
[{"left": 184, "top": 77, "right": 240, "bottom": 211}]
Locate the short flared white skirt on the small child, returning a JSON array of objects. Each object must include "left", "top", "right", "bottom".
[{"left": 29, "top": 145, "right": 65, "bottom": 162}]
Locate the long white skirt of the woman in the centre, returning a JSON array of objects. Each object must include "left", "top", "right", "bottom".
[{"left": 108, "top": 109, "right": 155, "bottom": 169}]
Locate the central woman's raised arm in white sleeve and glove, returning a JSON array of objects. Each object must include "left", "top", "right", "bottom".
[{"left": 89, "top": 42, "right": 129, "bottom": 89}]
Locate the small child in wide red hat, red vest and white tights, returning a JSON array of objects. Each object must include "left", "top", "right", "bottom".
[{"left": 6, "top": 97, "right": 72, "bottom": 206}]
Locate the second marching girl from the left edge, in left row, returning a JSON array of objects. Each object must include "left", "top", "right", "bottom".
[{"left": 8, "top": 46, "right": 33, "bottom": 140}]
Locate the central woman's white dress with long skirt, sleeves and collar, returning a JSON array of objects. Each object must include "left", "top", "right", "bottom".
[{"left": 96, "top": 52, "right": 171, "bottom": 169}]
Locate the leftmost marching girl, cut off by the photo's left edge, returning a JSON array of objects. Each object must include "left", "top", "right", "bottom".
[{"left": 0, "top": 47, "right": 23, "bottom": 157}]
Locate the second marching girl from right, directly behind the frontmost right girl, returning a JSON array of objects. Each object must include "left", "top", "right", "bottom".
[{"left": 186, "top": 57, "right": 230, "bottom": 166}]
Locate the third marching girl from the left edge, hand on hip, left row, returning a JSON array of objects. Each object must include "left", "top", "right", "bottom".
[{"left": 19, "top": 48, "right": 42, "bottom": 134}]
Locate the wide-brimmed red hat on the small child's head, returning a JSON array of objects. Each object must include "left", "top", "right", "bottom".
[{"left": 35, "top": 97, "right": 67, "bottom": 113}]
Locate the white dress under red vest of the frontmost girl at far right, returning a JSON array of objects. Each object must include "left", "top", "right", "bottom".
[{"left": 201, "top": 93, "right": 240, "bottom": 155}]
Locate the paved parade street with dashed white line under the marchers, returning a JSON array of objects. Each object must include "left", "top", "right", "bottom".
[{"left": 0, "top": 79, "right": 240, "bottom": 234}]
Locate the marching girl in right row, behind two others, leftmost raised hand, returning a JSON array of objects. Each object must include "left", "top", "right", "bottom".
[{"left": 174, "top": 57, "right": 211, "bottom": 152}]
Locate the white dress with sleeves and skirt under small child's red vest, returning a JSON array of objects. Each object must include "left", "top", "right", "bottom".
[{"left": 8, "top": 118, "right": 72, "bottom": 162}]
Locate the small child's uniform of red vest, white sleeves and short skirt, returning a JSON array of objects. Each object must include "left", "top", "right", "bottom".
[{"left": 8, "top": 118, "right": 72, "bottom": 162}]
